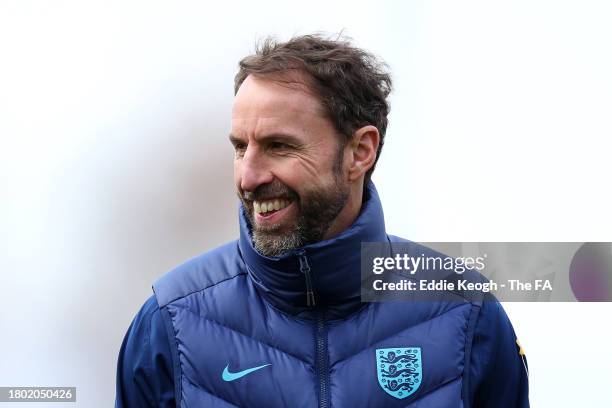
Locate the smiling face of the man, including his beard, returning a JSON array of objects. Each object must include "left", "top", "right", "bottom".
[{"left": 230, "top": 75, "right": 349, "bottom": 256}]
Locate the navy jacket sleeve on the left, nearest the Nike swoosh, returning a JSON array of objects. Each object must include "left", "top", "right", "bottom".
[{"left": 115, "top": 296, "right": 176, "bottom": 408}]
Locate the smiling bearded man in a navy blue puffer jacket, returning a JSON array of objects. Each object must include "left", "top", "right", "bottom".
[{"left": 116, "top": 36, "right": 529, "bottom": 408}]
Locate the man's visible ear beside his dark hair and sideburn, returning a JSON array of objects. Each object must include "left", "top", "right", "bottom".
[{"left": 348, "top": 125, "right": 380, "bottom": 181}]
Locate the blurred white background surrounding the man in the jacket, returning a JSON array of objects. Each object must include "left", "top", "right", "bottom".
[{"left": 0, "top": 0, "right": 612, "bottom": 407}]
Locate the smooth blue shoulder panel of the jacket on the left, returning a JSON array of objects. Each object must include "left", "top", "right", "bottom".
[{"left": 153, "top": 240, "right": 246, "bottom": 308}]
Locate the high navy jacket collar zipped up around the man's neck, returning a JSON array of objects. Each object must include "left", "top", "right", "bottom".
[{"left": 238, "top": 182, "right": 387, "bottom": 318}]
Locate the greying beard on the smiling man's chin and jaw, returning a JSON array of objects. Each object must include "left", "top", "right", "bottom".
[{"left": 246, "top": 179, "right": 349, "bottom": 256}]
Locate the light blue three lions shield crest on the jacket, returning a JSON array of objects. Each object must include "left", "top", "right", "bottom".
[{"left": 376, "top": 347, "right": 423, "bottom": 399}]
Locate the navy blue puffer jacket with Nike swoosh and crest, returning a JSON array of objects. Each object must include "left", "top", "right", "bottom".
[{"left": 117, "top": 184, "right": 528, "bottom": 408}]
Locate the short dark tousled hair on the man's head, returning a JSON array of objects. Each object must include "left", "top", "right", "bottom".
[{"left": 234, "top": 34, "right": 392, "bottom": 180}]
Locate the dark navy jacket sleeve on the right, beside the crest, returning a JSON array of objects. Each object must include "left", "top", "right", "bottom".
[{"left": 469, "top": 299, "right": 529, "bottom": 408}]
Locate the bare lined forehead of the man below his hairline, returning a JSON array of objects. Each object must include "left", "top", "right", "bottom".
[{"left": 232, "top": 75, "right": 331, "bottom": 136}]
